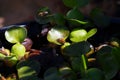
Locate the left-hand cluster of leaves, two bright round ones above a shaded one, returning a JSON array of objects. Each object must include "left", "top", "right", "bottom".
[{"left": 0, "top": 25, "right": 40, "bottom": 80}]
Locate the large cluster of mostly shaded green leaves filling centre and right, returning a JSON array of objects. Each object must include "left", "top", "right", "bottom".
[{"left": 36, "top": 0, "right": 120, "bottom": 80}]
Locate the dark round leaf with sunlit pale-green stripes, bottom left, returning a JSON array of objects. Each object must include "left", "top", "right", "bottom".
[{"left": 17, "top": 60, "right": 40, "bottom": 80}]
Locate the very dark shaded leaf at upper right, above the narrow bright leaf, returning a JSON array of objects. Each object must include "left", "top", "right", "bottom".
[{"left": 90, "top": 8, "right": 110, "bottom": 27}]
